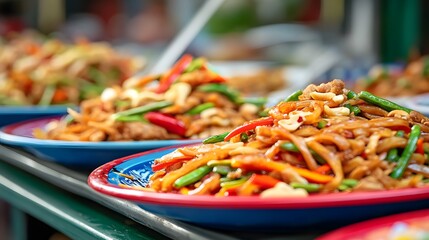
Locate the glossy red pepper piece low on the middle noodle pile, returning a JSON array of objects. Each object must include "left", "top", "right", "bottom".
[{"left": 144, "top": 112, "right": 186, "bottom": 136}]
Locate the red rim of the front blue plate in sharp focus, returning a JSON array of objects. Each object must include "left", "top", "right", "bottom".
[{"left": 88, "top": 144, "right": 429, "bottom": 209}]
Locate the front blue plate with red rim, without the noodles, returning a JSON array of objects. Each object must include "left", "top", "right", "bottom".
[{"left": 88, "top": 146, "right": 429, "bottom": 232}]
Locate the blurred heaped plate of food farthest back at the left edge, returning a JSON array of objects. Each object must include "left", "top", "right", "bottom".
[{"left": 0, "top": 33, "right": 145, "bottom": 125}]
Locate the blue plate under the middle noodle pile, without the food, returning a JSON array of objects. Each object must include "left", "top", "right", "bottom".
[{"left": 0, "top": 117, "right": 201, "bottom": 169}]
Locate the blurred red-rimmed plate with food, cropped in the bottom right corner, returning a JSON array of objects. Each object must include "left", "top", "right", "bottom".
[{"left": 317, "top": 209, "right": 429, "bottom": 240}]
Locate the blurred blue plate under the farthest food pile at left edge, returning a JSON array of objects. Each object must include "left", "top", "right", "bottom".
[{"left": 0, "top": 106, "right": 67, "bottom": 126}]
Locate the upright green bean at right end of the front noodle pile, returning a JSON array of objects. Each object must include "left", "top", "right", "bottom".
[{"left": 390, "top": 125, "right": 421, "bottom": 179}]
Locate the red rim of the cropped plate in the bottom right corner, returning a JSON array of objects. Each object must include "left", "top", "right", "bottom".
[{"left": 317, "top": 209, "right": 429, "bottom": 240}]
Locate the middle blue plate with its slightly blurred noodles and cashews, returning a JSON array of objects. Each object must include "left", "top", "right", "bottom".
[{"left": 0, "top": 55, "right": 267, "bottom": 167}]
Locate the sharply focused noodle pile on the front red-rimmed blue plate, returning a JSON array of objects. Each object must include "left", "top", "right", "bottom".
[{"left": 145, "top": 80, "right": 429, "bottom": 197}]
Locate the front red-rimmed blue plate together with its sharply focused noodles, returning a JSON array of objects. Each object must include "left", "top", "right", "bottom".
[{"left": 88, "top": 80, "right": 429, "bottom": 231}]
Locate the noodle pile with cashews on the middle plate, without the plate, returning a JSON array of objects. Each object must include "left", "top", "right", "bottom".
[{"left": 34, "top": 55, "right": 266, "bottom": 142}]
